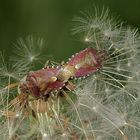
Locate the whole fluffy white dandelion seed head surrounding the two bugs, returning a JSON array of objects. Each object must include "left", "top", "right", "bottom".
[{"left": 0, "top": 6, "right": 140, "bottom": 140}]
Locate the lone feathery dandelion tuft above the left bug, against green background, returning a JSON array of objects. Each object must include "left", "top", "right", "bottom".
[{"left": 11, "top": 36, "right": 45, "bottom": 67}]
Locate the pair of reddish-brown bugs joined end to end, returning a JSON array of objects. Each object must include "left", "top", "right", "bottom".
[{"left": 20, "top": 48, "right": 104, "bottom": 98}]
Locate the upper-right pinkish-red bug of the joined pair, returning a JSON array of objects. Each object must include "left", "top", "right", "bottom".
[{"left": 67, "top": 48, "right": 104, "bottom": 77}]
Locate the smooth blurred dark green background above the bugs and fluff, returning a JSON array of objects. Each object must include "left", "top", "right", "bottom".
[{"left": 0, "top": 0, "right": 140, "bottom": 62}]
